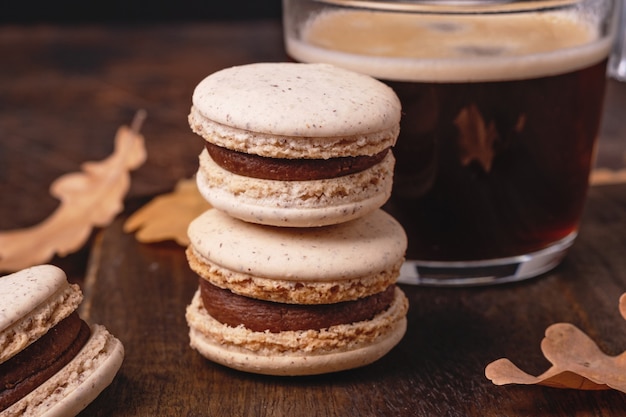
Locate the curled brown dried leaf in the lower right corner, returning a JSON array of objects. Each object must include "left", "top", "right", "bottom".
[{"left": 485, "top": 294, "right": 626, "bottom": 392}]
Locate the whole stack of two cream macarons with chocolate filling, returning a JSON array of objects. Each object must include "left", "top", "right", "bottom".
[{"left": 186, "top": 63, "right": 408, "bottom": 375}]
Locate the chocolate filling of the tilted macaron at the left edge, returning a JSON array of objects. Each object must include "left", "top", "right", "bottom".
[{"left": 0, "top": 312, "right": 91, "bottom": 411}]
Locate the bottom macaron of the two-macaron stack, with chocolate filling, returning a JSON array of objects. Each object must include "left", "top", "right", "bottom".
[{"left": 186, "top": 209, "right": 408, "bottom": 375}]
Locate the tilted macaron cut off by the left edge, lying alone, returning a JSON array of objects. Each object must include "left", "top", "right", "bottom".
[{"left": 0, "top": 265, "right": 124, "bottom": 416}]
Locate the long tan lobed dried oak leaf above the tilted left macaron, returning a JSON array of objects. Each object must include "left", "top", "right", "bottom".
[{"left": 0, "top": 112, "right": 146, "bottom": 271}]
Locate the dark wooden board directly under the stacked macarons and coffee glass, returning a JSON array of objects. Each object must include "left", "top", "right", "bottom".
[{"left": 74, "top": 185, "right": 626, "bottom": 416}]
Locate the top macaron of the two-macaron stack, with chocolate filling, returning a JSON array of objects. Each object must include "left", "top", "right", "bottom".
[{"left": 188, "top": 63, "right": 401, "bottom": 227}]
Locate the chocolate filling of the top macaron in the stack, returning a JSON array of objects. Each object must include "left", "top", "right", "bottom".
[{"left": 206, "top": 142, "right": 389, "bottom": 181}]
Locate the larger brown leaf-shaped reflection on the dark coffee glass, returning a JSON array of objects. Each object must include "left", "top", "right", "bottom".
[{"left": 454, "top": 104, "right": 498, "bottom": 172}]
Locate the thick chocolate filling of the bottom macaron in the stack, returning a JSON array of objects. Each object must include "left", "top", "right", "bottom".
[{"left": 200, "top": 279, "right": 395, "bottom": 333}]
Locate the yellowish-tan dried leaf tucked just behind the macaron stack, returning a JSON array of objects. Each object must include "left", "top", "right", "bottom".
[{"left": 124, "top": 179, "right": 211, "bottom": 246}]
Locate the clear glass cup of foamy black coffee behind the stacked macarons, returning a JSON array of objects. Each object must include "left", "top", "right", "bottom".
[{"left": 283, "top": 0, "right": 621, "bottom": 286}]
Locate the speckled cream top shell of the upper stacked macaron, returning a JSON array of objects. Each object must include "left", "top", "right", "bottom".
[{"left": 189, "top": 63, "right": 401, "bottom": 159}]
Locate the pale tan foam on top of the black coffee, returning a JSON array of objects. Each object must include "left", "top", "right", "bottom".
[{"left": 286, "top": 10, "right": 610, "bottom": 82}]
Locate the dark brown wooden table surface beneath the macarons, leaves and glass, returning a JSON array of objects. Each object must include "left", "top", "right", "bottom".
[{"left": 0, "top": 21, "right": 626, "bottom": 416}]
